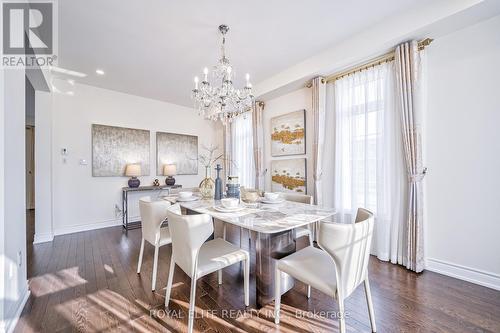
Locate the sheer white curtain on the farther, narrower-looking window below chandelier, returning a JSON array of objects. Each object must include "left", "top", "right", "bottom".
[{"left": 231, "top": 115, "right": 255, "bottom": 188}]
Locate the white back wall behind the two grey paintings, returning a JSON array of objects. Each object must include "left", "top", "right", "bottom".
[{"left": 50, "top": 81, "right": 222, "bottom": 234}]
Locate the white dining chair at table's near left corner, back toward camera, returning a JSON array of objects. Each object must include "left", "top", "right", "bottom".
[{"left": 165, "top": 204, "right": 250, "bottom": 333}]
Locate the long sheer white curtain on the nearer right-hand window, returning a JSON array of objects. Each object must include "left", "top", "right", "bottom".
[{"left": 327, "top": 63, "right": 406, "bottom": 262}]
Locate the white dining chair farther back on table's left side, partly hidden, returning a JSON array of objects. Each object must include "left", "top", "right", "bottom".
[{"left": 137, "top": 197, "right": 172, "bottom": 291}]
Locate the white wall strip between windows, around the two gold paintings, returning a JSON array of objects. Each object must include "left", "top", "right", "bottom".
[{"left": 263, "top": 88, "right": 314, "bottom": 194}]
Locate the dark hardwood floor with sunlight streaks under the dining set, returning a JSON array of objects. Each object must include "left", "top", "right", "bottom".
[{"left": 15, "top": 220, "right": 500, "bottom": 332}]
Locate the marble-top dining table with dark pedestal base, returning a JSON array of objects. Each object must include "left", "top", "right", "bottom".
[{"left": 164, "top": 196, "right": 335, "bottom": 308}]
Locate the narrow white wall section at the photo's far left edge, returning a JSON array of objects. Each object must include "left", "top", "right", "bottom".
[{"left": 0, "top": 69, "right": 28, "bottom": 331}]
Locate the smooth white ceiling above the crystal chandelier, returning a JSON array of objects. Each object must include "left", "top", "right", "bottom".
[{"left": 58, "top": 0, "right": 430, "bottom": 106}]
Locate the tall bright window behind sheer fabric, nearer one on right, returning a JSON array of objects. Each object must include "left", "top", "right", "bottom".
[{"left": 334, "top": 64, "right": 402, "bottom": 219}]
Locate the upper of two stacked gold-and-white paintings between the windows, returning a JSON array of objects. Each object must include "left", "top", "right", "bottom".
[{"left": 271, "top": 110, "right": 306, "bottom": 156}]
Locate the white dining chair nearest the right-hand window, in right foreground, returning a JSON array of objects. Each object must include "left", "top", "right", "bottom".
[{"left": 274, "top": 208, "right": 377, "bottom": 333}]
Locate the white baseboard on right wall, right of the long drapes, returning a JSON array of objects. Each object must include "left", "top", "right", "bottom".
[{"left": 425, "top": 258, "right": 500, "bottom": 290}]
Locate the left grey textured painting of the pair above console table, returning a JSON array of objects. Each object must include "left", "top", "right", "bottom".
[{"left": 92, "top": 124, "right": 150, "bottom": 177}]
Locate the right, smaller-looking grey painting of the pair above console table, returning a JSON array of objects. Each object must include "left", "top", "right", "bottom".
[{"left": 156, "top": 132, "right": 198, "bottom": 176}]
